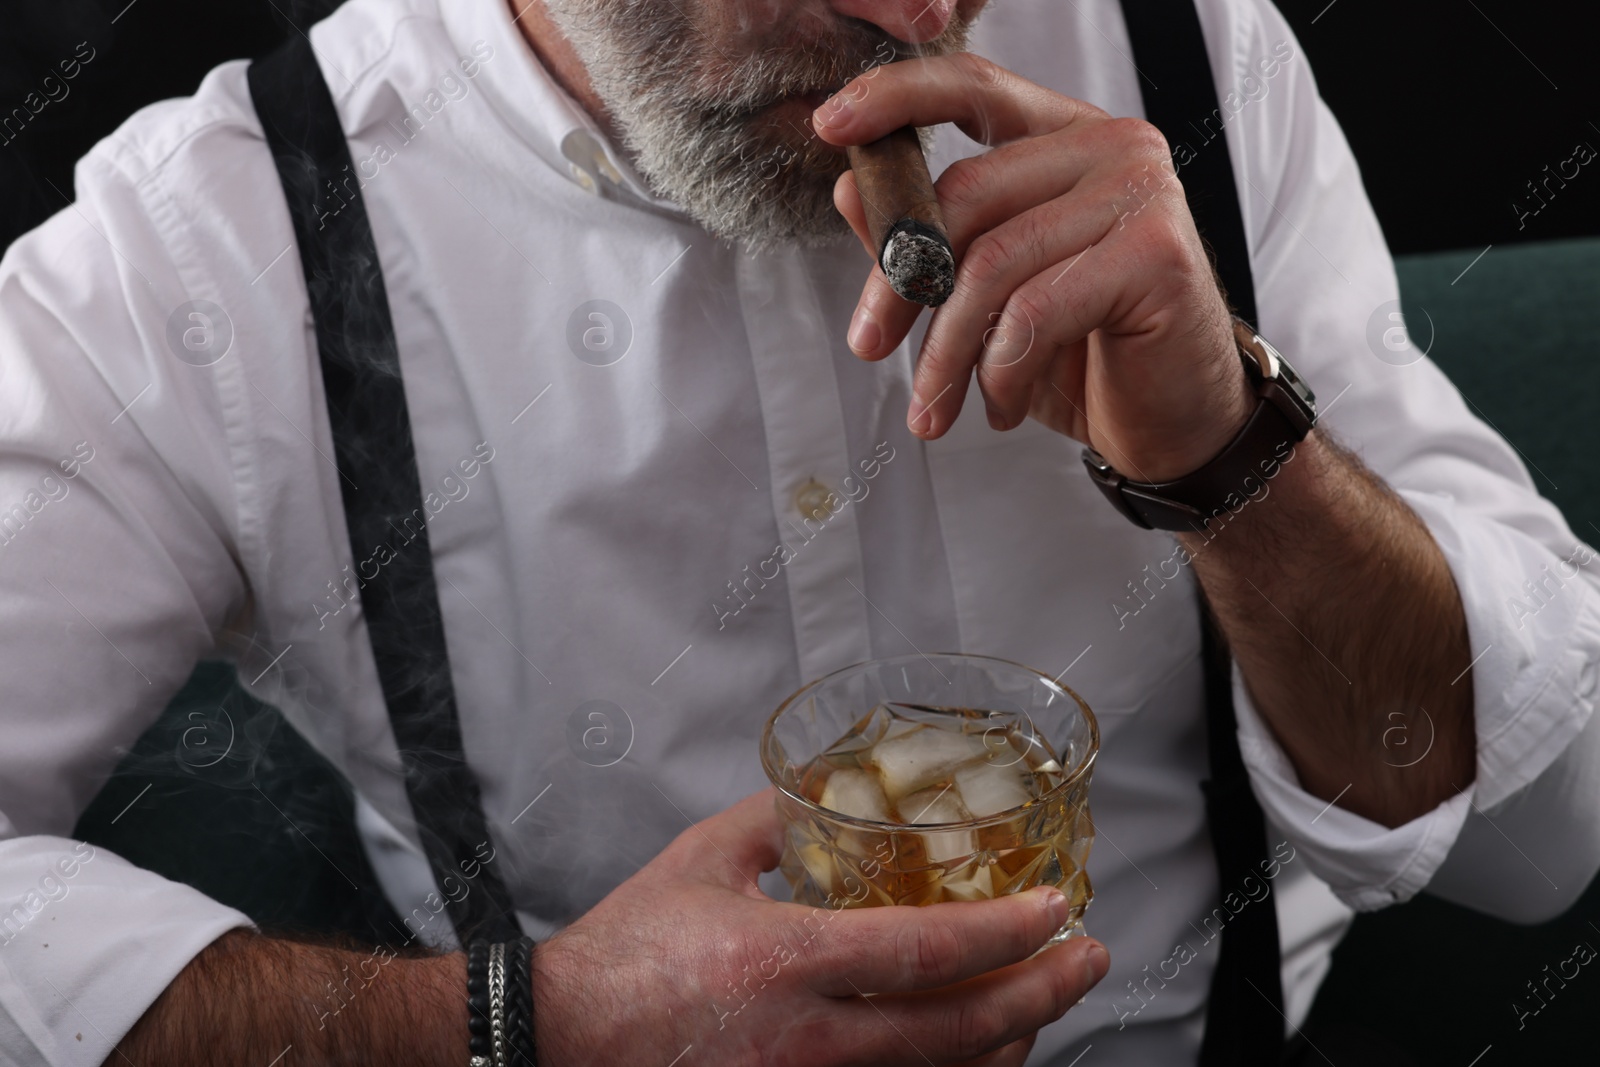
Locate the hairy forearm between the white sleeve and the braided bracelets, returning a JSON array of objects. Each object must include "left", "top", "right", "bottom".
[{"left": 116, "top": 929, "right": 467, "bottom": 1067}]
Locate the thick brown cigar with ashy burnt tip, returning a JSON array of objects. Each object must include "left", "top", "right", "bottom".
[{"left": 848, "top": 126, "right": 955, "bottom": 307}]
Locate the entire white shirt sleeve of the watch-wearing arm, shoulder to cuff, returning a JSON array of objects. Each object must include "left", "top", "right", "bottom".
[{"left": 1209, "top": 0, "right": 1600, "bottom": 921}]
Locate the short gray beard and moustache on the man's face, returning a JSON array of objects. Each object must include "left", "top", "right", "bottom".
[{"left": 546, "top": 0, "right": 970, "bottom": 250}]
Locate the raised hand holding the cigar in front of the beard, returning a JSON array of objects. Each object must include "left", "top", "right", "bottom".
[{"left": 811, "top": 53, "right": 1254, "bottom": 463}]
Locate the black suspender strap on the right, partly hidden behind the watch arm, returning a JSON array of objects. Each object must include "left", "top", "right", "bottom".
[{"left": 1122, "top": 0, "right": 1285, "bottom": 1067}]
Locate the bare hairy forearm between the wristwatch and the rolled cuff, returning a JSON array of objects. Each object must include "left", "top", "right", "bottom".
[{"left": 1179, "top": 430, "right": 1477, "bottom": 827}]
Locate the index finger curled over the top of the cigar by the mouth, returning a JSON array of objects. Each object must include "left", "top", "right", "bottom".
[{"left": 811, "top": 51, "right": 1106, "bottom": 146}]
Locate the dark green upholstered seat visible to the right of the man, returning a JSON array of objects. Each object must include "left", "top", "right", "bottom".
[{"left": 1307, "top": 238, "right": 1600, "bottom": 1067}]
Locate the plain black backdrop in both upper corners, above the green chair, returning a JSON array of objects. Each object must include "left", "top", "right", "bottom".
[{"left": 0, "top": 0, "right": 1600, "bottom": 254}]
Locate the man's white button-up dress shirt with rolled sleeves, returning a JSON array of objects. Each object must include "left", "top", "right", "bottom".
[{"left": 0, "top": 0, "right": 1600, "bottom": 1067}]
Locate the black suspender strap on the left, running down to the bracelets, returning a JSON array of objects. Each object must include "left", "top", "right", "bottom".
[{"left": 250, "top": 35, "right": 522, "bottom": 944}]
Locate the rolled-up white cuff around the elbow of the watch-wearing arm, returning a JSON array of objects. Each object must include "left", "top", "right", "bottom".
[{"left": 1234, "top": 491, "right": 1600, "bottom": 923}]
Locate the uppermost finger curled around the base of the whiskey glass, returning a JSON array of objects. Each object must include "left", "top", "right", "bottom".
[{"left": 800, "top": 886, "right": 1070, "bottom": 997}]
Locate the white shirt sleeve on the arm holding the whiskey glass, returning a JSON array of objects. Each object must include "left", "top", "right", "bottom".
[{"left": 0, "top": 119, "right": 259, "bottom": 1067}]
